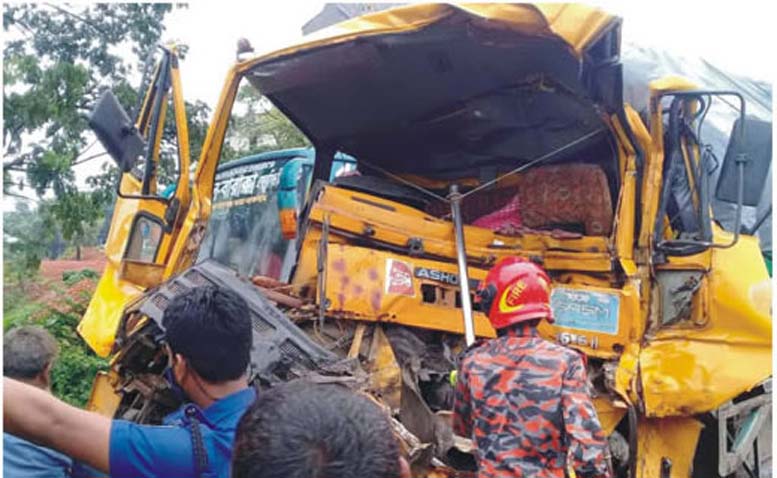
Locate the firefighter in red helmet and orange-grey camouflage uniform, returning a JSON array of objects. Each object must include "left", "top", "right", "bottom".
[{"left": 453, "top": 257, "right": 612, "bottom": 478}]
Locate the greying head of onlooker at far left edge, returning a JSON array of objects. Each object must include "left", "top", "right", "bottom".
[{"left": 3, "top": 325, "right": 59, "bottom": 389}]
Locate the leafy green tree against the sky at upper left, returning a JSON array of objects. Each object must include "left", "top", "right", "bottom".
[{"left": 3, "top": 3, "right": 183, "bottom": 258}]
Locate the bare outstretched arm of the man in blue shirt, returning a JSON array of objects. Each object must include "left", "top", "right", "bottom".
[{"left": 3, "top": 378, "right": 111, "bottom": 472}]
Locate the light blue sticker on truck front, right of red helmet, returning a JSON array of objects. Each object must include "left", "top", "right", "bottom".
[{"left": 550, "top": 287, "right": 620, "bottom": 335}]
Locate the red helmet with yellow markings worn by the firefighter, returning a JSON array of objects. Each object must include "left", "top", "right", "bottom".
[{"left": 477, "top": 257, "right": 553, "bottom": 329}]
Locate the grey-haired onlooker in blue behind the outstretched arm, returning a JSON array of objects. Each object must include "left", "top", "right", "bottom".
[{"left": 3, "top": 325, "right": 73, "bottom": 478}]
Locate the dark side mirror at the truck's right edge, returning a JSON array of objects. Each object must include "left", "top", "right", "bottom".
[{"left": 715, "top": 117, "right": 772, "bottom": 206}]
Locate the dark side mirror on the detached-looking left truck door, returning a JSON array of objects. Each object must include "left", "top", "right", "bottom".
[{"left": 89, "top": 90, "right": 145, "bottom": 173}]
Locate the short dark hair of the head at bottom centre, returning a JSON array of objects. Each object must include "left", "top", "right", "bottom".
[{"left": 232, "top": 382, "right": 401, "bottom": 478}]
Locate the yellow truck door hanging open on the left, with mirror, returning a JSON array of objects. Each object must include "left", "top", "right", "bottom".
[{"left": 78, "top": 46, "right": 191, "bottom": 356}]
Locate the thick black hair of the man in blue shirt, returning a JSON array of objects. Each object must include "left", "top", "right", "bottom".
[{"left": 162, "top": 286, "right": 252, "bottom": 383}]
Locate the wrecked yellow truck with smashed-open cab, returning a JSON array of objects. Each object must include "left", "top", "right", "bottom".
[{"left": 79, "top": 4, "right": 772, "bottom": 478}]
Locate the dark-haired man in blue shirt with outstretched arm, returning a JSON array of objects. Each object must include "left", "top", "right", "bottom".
[{"left": 3, "top": 286, "right": 255, "bottom": 478}]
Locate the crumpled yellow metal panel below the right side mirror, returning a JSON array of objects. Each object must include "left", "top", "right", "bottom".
[{"left": 640, "top": 226, "right": 772, "bottom": 417}]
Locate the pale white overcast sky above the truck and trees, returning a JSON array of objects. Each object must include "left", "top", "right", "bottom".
[{"left": 4, "top": 0, "right": 777, "bottom": 210}]
